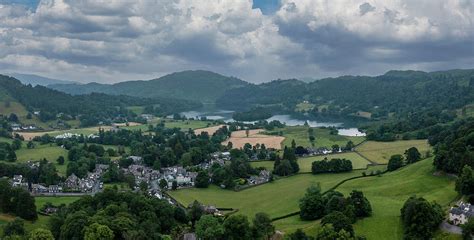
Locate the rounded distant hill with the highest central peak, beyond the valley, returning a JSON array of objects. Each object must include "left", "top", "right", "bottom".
[{"left": 48, "top": 70, "right": 249, "bottom": 103}]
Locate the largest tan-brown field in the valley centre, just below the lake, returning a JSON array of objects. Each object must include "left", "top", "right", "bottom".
[{"left": 222, "top": 129, "right": 285, "bottom": 149}]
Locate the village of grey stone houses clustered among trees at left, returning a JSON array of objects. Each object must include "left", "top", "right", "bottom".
[{"left": 6, "top": 151, "right": 270, "bottom": 202}]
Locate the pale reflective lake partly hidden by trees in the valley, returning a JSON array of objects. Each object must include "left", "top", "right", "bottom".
[{"left": 181, "top": 110, "right": 365, "bottom": 136}]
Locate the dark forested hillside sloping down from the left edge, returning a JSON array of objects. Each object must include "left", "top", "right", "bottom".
[{"left": 0, "top": 75, "right": 199, "bottom": 126}]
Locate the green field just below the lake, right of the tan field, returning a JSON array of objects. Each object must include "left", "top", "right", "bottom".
[{"left": 266, "top": 126, "right": 365, "bottom": 148}]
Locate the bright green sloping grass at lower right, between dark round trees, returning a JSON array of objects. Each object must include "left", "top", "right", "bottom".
[{"left": 337, "top": 158, "right": 457, "bottom": 239}]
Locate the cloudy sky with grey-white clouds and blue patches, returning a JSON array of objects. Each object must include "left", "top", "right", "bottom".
[{"left": 0, "top": 0, "right": 474, "bottom": 83}]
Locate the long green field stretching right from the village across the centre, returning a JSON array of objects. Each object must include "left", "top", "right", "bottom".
[{"left": 169, "top": 166, "right": 384, "bottom": 217}]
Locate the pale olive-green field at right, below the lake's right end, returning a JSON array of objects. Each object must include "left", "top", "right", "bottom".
[{"left": 356, "top": 140, "right": 431, "bottom": 164}]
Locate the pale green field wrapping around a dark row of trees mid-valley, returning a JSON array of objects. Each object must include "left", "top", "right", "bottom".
[{"left": 250, "top": 152, "right": 370, "bottom": 173}]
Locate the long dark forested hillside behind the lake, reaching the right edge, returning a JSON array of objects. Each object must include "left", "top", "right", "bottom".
[{"left": 217, "top": 70, "right": 474, "bottom": 141}]
